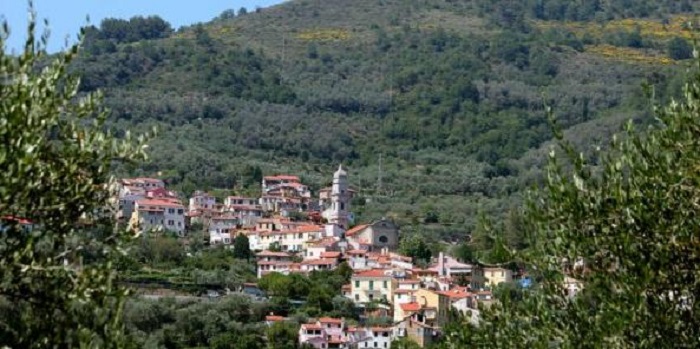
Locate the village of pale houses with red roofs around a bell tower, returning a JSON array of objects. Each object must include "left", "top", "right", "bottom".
[{"left": 118, "top": 166, "right": 579, "bottom": 349}]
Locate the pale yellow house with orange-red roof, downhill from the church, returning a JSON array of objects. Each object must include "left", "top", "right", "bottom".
[{"left": 350, "top": 269, "right": 397, "bottom": 305}]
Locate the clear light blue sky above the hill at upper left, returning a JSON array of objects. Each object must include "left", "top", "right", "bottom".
[{"left": 0, "top": 0, "right": 283, "bottom": 52}]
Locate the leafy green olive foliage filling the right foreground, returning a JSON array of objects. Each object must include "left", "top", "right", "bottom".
[{"left": 445, "top": 58, "right": 700, "bottom": 348}]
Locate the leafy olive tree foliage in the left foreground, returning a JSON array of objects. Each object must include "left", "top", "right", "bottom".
[{"left": 0, "top": 11, "right": 149, "bottom": 348}]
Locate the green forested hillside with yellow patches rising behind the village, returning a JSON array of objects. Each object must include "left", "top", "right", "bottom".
[{"left": 74, "top": 0, "right": 699, "bottom": 242}]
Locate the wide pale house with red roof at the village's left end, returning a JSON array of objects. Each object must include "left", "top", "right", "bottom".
[{"left": 130, "top": 199, "right": 185, "bottom": 236}]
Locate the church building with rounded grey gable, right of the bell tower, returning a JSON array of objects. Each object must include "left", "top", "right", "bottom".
[{"left": 345, "top": 219, "right": 399, "bottom": 251}]
